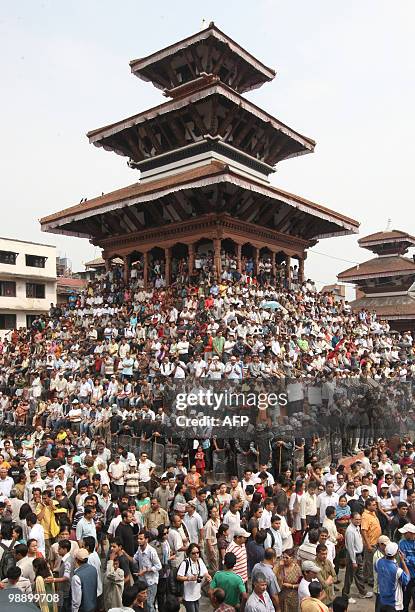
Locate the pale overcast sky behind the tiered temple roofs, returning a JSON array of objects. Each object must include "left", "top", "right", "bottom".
[{"left": 0, "top": 0, "right": 415, "bottom": 283}]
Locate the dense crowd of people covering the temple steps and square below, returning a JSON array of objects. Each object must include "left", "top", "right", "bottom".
[{"left": 0, "top": 257, "right": 415, "bottom": 612}]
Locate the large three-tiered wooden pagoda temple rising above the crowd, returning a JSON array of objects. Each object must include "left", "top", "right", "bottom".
[{"left": 40, "top": 23, "right": 359, "bottom": 284}]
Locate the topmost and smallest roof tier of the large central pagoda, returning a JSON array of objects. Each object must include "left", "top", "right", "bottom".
[{"left": 130, "top": 21, "right": 275, "bottom": 98}]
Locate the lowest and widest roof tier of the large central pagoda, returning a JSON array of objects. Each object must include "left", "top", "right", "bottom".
[{"left": 41, "top": 163, "right": 358, "bottom": 239}]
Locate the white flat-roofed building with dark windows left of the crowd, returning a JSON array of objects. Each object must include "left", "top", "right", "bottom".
[{"left": 0, "top": 238, "right": 56, "bottom": 337}]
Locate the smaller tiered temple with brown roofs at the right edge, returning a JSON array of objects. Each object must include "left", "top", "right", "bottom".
[{"left": 338, "top": 230, "right": 415, "bottom": 331}]
